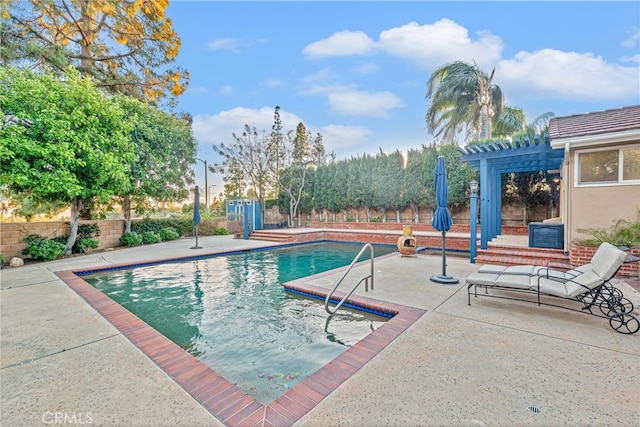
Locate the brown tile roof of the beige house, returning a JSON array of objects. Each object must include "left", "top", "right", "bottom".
[{"left": 549, "top": 105, "right": 640, "bottom": 140}]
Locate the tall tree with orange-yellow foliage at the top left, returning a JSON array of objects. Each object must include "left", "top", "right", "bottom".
[{"left": 0, "top": 0, "right": 188, "bottom": 107}]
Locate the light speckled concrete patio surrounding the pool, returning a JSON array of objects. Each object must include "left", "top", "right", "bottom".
[{"left": 0, "top": 236, "right": 640, "bottom": 426}]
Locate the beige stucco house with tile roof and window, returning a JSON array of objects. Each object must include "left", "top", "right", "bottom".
[{"left": 549, "top": 105, "right": 640, "bottom": 250}]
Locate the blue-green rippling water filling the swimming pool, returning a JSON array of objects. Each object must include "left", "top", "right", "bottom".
[{"left": 83, "top": 242, "right": 396, "bottom": 404}]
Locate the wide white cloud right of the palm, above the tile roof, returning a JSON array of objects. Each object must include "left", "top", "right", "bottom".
[{"left": 494, "top": 49, "right": 640, "bottom": 101}]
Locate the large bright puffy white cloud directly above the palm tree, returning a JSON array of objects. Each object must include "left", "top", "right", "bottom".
[{"left": 378, "top": 18, "right": 503, "bottom": 68}]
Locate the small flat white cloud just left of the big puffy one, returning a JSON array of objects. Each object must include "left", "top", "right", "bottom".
[{"left": 302, "top": 30, "right": 375, "bottom": 58}]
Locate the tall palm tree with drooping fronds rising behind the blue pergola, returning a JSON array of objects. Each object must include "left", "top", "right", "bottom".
[{"left": 425, "top": 61, "right": 503, "bottom": 142}]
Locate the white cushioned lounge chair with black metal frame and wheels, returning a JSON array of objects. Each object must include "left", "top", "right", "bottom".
[{"left": 466, "top": 242, "right": 640, "bottom": 334}]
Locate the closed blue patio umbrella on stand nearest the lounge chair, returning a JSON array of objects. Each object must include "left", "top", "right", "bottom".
[{"left": 431, "top": 156, "right": 458, "bottom": 284}]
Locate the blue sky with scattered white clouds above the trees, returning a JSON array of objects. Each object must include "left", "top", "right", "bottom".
[{"left": 166, "top": 0, "right": 640, "bottom": 199}]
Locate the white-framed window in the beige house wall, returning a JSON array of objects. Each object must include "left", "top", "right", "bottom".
[{"left": 576, "top": 146, "right": 640, "bottom": 185}]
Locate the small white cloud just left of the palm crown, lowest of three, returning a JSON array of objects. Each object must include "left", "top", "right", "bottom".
[{"left": 329, "top": 90, "right": 404, "bottom": 118}]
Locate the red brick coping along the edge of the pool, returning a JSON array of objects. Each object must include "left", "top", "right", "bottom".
[{"left": 55, "top": 260, "right": 426, "bottom": 426}]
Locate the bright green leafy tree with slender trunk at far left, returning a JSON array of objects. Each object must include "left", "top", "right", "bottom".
[{"left": 0, "top": 67, "right": 135, "bottom": 254}]
